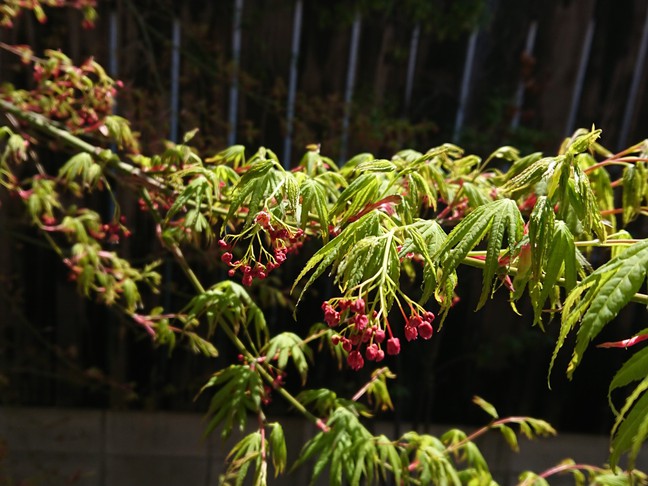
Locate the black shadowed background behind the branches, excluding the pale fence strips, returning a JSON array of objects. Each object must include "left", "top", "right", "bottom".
[{"left": 0, "top": 0, "right": 648, "bottom": 433}]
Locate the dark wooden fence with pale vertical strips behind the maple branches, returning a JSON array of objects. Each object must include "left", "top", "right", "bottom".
[{"left": 0, "top": 0, "right": 648, "bottom": 432}]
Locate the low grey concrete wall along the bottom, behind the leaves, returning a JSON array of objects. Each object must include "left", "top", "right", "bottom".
[{"left": 0, "top": 408, "right": 648, "bottom": 486}]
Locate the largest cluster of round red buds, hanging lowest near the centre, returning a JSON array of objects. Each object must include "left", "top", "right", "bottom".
[{"left": 322, "top": 298, "right": 400, "bottom": 371}]
